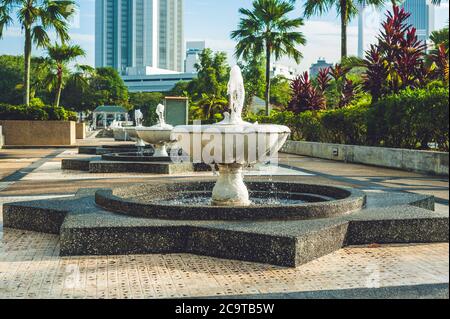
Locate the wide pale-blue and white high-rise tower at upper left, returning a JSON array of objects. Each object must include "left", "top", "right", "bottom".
[{"left": 95, "top": 0, "right": 184, "bottom": 74}]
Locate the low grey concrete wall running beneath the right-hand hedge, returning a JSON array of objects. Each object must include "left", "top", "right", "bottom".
[{"left": 281, "top": 141, "right": 449, "bottom": 176}]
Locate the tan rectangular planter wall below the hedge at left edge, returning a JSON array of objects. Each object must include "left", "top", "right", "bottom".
[{"left": 0, "top": 120, "right": 76, "bottom": 146}]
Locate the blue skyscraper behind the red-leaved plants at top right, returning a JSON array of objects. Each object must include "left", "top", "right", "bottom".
[{"left": 403, "top": 0, "right": 435, "bottom": 42}]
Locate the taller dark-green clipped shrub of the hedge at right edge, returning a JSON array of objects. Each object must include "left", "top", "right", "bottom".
[{"left": 368, "top": 84, "right": 449, "bottom": 151}]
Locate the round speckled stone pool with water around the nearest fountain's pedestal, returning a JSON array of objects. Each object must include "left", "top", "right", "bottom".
[{"left": 95, "top": 181, "right": 366, "bottom": 220}]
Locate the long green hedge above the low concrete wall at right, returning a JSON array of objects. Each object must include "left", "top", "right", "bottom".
[{"left": 248, "top": 85, "right": 449, "bottom": 151}]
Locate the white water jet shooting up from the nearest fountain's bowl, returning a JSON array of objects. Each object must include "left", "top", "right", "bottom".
[{"left": 228, "top": 65, "right": 245, "bottom": 124}]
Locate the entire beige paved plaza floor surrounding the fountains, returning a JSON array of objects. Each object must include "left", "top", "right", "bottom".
[{"left": 0, "top": 139, "right": 449, "bottom": 298}]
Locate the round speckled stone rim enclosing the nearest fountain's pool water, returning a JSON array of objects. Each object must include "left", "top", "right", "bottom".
[{"left": 95, "top": 181, "right": 366, "bottom": 220}]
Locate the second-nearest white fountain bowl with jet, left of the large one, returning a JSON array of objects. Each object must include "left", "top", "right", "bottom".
[{"left": 136, "top": 104, "right": 173, "bottom": 157}]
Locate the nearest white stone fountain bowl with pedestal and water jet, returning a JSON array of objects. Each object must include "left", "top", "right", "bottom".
[{"left": 172, "top": 66, "right": 291, "bottom": 206}]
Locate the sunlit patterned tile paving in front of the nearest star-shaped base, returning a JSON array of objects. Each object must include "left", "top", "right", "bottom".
[{"left": 0, "top": 226, "right": 449, "bottom": 298}]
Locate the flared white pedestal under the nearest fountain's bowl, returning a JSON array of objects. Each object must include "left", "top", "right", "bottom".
[{"left": 212, "top": 163, "right": 251, "bottom": 206}]
